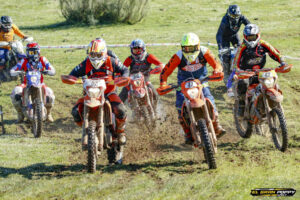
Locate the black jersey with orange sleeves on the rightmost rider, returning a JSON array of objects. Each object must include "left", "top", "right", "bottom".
[{"left": 233, "top": 40, "right": 283, "bottom": 70}]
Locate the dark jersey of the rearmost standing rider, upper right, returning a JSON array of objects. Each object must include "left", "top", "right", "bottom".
[{"left": 216, "top": 14, "right": 250, "bottom": 49}]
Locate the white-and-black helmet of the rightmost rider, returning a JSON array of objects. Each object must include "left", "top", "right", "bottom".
[{"left": 243, "top": 24, "right": 260, "bottom": 48}]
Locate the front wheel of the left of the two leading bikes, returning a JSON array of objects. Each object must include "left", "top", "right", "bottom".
[{"left": 87, "top": 121, "right": 97, "bottom": 173}]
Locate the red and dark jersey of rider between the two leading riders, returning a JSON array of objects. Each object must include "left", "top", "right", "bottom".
[{"left": 124, "top": 54, "right": 162, "bottom": 80}]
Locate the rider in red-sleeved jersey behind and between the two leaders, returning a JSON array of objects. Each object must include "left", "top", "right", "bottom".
[{"left": 119, "top": 39, "right": 164, "bottom": 111}]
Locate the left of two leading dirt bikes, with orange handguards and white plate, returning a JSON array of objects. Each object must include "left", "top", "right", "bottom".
[{"left": 61, "top": 75, "right": 129, "bottom": 173}]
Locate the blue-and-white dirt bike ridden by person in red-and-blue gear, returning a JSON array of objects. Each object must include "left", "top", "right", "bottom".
[{"left": 12, "top": 69, "right": 47, "bottom": 138}]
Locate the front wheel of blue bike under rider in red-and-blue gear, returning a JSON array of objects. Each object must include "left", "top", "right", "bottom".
[{"left": 32, "top": 101, "right": 43, "bottom": 138}]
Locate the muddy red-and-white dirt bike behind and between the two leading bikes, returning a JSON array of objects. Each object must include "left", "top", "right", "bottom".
[{"left": 128, "top": 68, "right": 161, "bottom": 131}]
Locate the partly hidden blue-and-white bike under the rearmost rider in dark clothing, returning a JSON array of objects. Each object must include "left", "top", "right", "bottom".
[{"left": 219, "top": 47, "right": 238, "bottom": 84}]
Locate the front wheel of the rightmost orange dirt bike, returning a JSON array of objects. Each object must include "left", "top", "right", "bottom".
[{"left": 270, "top": 108, "right": 288, "bottom": 152}]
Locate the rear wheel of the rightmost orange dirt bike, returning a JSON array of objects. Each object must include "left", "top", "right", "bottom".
[{"left": 233, "top": 100, "right": 253, "bottom": 138}]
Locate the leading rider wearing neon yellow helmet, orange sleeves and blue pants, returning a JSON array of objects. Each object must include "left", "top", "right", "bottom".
[{"left": 160, "top": 33, "right": 226, "bottom": 144}]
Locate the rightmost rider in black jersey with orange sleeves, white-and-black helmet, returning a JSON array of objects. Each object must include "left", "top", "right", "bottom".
[{"left": 234, "top": 24, "right": 286, "bottom": 116}]
